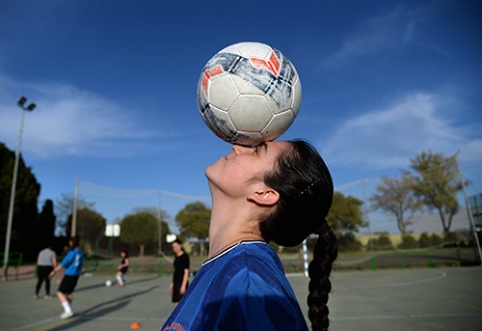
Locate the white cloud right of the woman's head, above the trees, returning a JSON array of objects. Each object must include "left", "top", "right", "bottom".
[{"left": 320, "top": 93, "right": 482, "bottom": 169}]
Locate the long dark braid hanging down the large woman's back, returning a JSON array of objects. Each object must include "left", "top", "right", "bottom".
[{"left": 307, "top": 230, "right": 338, "bottom": 331}]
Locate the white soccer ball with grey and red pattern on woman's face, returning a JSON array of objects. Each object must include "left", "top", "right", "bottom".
[{"left": 197, "top": 42, "right": 301, "bottom": 146}]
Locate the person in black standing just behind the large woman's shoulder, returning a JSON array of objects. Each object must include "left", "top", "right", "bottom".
[{"left": 168, "top": 239, "right": 189, "bottom": 304}]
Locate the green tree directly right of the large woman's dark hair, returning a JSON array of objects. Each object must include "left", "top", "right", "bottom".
[{"left": 326, "top": 192, "right": 368, "bottom": 235}]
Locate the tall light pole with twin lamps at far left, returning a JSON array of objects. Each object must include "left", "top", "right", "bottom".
[{"left": 3, "top": 96, "right": 37, "bottom": 281}]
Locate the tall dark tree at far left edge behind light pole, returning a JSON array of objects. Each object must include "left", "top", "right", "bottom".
[{"left": 0, "top": 143, "right": 40, "bottom": 259}]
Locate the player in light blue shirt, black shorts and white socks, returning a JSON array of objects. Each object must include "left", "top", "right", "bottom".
[{"left": 49, "top": 237, "right": 84, "bottom": 319}]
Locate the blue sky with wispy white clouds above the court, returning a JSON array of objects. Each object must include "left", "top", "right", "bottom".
[{"left": 0, "top": 0, "right": 482, "bottom": 235}]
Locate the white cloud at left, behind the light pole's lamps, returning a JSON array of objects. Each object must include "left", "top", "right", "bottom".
[{"left": 0, "top": 79, "right": 157, "bottom": 157}]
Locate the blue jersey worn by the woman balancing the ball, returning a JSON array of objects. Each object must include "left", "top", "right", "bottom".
[{"left": 161, "top": 241, "right": 308, "bottom": 331}]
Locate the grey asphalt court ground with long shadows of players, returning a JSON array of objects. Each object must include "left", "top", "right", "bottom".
[{"left": 0, "top": 267, "right": 482, "bottom": 331}]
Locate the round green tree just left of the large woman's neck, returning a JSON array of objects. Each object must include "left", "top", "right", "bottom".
[{"left": 176, "top": 201, "right": 211, "bottom": 256}]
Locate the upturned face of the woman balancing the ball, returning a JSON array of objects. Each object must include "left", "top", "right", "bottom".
[{"left": 206, "top": 141, "right": 289, "bottom": 195}]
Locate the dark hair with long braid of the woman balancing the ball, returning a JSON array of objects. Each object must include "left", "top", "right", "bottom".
[{"left": 260, "top": 139, "right": 338, "bottom": 331}]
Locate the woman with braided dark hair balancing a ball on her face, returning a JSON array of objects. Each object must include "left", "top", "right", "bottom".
[{"left": 162, "top": 140, "right": 337, "bottom": 331}]
